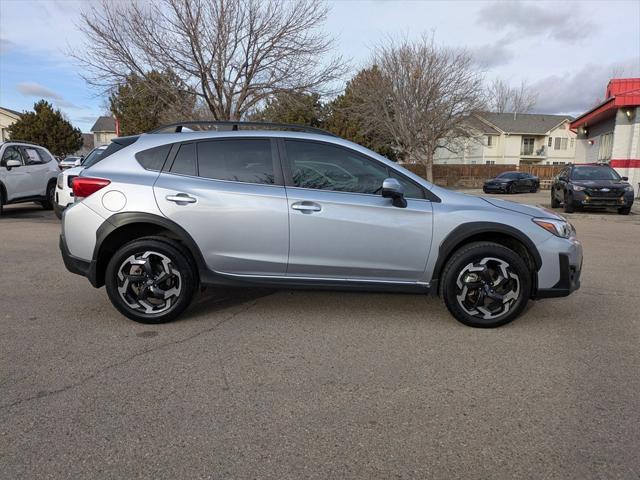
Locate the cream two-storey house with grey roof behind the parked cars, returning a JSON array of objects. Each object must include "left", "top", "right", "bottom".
[{"left": 434, "top": 112, "right": 576, "bottom": 165}]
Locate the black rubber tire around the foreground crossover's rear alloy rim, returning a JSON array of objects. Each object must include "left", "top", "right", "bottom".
[{"left": 105, "top": 237, "right": 197, "bottom": 324}]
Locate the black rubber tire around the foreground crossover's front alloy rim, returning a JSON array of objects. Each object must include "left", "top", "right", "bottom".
[{"left": 441, "top": 242, "right": 531, "bottom": 328}]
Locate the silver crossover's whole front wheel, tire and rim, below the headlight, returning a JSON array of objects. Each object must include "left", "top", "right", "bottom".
[{"left": 442, "top": 242, "right": 531, "bottom": 328}]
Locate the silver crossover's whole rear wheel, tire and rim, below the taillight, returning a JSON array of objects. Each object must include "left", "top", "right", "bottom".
[{"left": 105, "top": 237, "right": 196, "bottom": 323}]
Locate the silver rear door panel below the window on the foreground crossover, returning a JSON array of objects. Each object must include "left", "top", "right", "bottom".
[{"left": 154, "top": 173, "right": 289, "bottom": 275}]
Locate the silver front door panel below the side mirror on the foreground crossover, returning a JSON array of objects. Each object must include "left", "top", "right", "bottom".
[{"left": 287, "top": 187, "right": 432, "bottom": 281}]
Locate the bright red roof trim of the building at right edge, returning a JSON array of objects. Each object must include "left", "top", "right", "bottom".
[{"left": 571, "top": 78, "right": 640, "bottom": 130}]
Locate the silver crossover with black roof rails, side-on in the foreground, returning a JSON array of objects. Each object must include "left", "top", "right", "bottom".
[{"left": 60, "top": 122, "right": 582, "bottom": 327}]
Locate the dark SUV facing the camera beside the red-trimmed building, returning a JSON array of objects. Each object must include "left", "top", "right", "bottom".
[{"left": 551, "top": 164, "right": 634, "bottom": 215}]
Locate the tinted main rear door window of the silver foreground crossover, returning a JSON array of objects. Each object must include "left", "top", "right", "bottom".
[{"left": 198, "top": 139, "right": 275, "bottom": 184}]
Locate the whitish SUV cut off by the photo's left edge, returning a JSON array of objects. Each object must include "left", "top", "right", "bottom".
[{"left": 0, "top": 141, "right": 59, "bottom": 215}]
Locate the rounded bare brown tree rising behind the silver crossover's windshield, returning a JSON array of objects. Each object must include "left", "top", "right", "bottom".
[{"left": 354, "top": 36, "right": 484, "bottom": 181}]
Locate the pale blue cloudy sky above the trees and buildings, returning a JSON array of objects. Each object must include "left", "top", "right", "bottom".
[{"left": 0, "top": 0, "right": 640, "bottom": 131}]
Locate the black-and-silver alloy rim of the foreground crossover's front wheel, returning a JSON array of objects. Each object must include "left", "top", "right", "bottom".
[{"left": 456, "top": 257, "right": 520, "bottom": 320}]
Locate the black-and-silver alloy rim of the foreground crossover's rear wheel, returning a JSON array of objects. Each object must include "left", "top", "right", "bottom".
[{"left": 117, "top": 251, "right": 182, "bottom": 315}]
